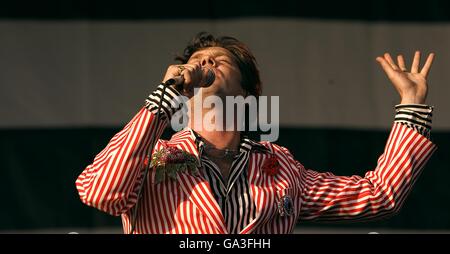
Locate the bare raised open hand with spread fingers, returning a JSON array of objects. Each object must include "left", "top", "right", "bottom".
[{"left": 376, "top": 51, "right": 434, "bottom": 104}]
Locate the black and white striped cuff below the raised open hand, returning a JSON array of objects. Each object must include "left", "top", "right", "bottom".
[{"left": 395, "top": 104, "right": 433, "bottom": 138}]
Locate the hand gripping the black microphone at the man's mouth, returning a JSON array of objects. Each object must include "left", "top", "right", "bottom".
[{"left": 163, "top": 64, "right": 216, "bottom": 98}]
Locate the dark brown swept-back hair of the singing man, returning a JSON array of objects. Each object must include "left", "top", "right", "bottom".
[{"left": 175, "top": 32, "right": 262, "bottom": 96}]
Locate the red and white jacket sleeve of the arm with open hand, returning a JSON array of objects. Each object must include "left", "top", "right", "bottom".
[{"left": 292, "top": 123, "right": 436, "bottom": 220}]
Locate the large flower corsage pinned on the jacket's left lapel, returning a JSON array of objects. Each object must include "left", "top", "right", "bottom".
[{"left": 150, "top": 147, "right": 198, "bottom": 183}]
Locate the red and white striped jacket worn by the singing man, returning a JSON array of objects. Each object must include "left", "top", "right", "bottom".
[{"left": 76, "top": 107, "right": 436, "bottom": 234}]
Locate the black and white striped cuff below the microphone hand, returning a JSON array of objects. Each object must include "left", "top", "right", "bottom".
[{"left": 145, "top": 84, "right": 187, "bottom": 119}]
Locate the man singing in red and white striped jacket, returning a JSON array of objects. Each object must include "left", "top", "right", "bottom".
[{"left": 76, "top": 33, "right": 436, "bottom": 234}]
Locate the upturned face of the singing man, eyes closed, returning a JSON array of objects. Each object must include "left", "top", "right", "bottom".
[{"left": 188, "top": 47, "right": 244, "bottom": 98}]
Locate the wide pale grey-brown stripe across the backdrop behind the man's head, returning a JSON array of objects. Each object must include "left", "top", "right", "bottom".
[{"left": 0, "top": 18, "right": 450, "bottom": 130}]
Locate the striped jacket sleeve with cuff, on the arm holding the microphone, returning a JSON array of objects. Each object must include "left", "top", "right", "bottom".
[{"left": 76, "top": 85, "right": 182, "bottom": 216}]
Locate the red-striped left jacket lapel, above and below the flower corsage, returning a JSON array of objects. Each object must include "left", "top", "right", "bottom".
[{"left": 168, "top": 129, "right": 227, "bottom": 234}]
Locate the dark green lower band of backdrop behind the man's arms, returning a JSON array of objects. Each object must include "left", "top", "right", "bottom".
[{"left": 0, "top": 128, "right": 450, "bottom": 230}]
